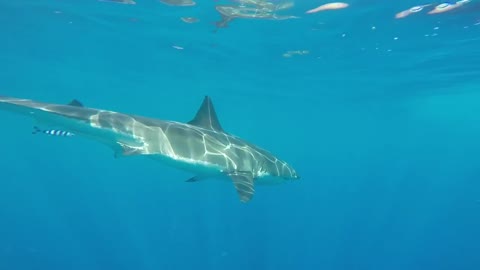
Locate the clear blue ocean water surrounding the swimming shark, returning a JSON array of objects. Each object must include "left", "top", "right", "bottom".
[{"left": 0, "top": 0, "right": 480, "bottom": 270}]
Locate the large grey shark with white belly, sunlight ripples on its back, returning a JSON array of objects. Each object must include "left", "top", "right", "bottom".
[{"left": 0, "top": 96, "right": 300, "bottom": 202}]
